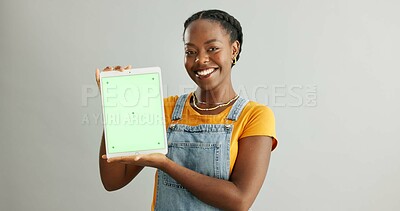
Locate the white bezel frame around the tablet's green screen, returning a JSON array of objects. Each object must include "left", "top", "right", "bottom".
[{"left": 100, "top": 67, "right": 168, "bottom": 158}]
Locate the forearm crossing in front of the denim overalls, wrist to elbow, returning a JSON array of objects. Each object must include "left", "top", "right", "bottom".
[{"left": 160, "top": 159, "right": 250, "bottom": 210}]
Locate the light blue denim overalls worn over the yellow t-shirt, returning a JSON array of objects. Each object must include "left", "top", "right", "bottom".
[{"left": 155, "top": 94, "right": 248, "bottom": 211}]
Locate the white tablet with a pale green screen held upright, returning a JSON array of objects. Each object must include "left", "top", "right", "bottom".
[{"left": 100, "top": 67, "right": 168, "bottom": 158}]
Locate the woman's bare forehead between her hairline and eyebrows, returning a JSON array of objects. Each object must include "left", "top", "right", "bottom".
[{"left": 184, "top": 19, "right": 229, "bottom": 42}]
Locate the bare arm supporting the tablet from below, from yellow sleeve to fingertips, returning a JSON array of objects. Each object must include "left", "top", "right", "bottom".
[{"left": 109, "top": 136, "right": 272, "bottom": 210}]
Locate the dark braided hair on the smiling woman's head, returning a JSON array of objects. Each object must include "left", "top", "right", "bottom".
[{"left": 183, "top": 10, "right": 243, "bottom": 67}]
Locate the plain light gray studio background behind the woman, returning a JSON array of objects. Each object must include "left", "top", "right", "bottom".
[{"left": 0, "top": 0, "right": 400, "bottom": 211}]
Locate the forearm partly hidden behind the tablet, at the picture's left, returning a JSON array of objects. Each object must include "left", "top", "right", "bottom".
[{"left": 99, "top": 132, "right": 143, "bottom": 191}]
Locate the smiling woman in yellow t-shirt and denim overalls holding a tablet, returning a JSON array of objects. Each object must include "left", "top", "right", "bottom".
[{"left": 96, "top": 10, "right": 277, "bottom": 210}]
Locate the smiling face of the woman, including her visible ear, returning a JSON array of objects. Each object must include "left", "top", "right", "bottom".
[{"left": 184, "top": 19, "right": 239, "bottom": 90}]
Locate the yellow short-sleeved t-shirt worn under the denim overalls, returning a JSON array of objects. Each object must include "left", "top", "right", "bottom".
[{"left": 152, "top": 94, "right": 278, "bottom": 210}]
